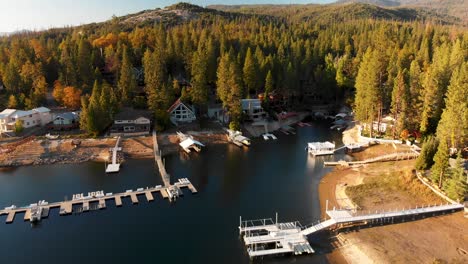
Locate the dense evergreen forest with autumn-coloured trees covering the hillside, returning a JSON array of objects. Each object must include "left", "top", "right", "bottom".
[{"left": 0, "top": 4, "right": 468, "bottom": 197}]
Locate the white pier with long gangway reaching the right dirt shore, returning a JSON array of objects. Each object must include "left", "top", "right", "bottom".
[{"left": 239, "top": 203, "right": 464, "bottom": 258}]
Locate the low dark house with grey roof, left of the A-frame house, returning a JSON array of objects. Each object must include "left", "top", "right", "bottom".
[{"left": 110, "top": 108, "right": 151, "bottom": 136}]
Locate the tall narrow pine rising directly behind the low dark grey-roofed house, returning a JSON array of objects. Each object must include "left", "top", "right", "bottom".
[{"left": 117, "top": 47, "right": 137, "bottom": 105}]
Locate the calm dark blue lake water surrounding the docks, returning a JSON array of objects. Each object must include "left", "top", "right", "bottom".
[{"left": 0, "top": 123, "right": 352, "bottom": 264}]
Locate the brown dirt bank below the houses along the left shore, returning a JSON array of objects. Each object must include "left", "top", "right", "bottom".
[{"left": 0, "top": 130, "right": 228, "bottom": 168}]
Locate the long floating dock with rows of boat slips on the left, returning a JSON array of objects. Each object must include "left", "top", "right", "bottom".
[{"left": 0, "top": 179, "right": 197, "bottom": 224}]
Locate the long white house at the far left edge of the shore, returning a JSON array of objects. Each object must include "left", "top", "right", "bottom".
[{"left": 0, "top": 107, "right": 52, "bottom": 133}]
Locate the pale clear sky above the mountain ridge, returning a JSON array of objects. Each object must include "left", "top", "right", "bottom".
[{"left": 0, "top": 0, "right": 334, "bottom": 33}]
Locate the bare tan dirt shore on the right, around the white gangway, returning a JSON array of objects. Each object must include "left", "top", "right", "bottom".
[{"left": 319, "top": 145, "right": 468, "bottom": 263}]
